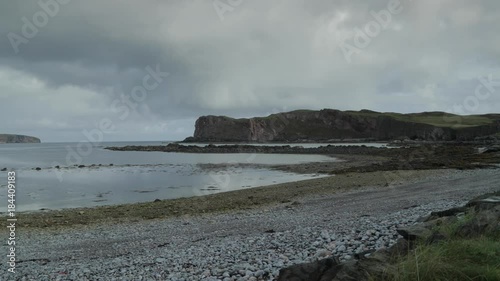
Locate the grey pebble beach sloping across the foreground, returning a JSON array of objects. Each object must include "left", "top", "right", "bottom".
[{"left": 0, "top": 169, "right": 500, "bottom": 281}]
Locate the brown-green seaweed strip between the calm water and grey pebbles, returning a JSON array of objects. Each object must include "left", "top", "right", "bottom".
[{"left": 0, "top": 170, "right": 454, "bottom": 232}]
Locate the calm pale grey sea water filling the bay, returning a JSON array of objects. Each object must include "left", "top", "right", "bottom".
[{"left": 0, "top": 142, "right": 336, "bottom": 212}]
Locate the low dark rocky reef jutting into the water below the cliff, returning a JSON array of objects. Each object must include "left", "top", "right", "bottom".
[{"left": 106, "top": 142, "right": 500, "bottom": 174}]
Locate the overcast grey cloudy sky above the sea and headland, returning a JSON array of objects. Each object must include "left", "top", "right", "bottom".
[{"left": 0, "top": 0, "right": 500, "bottom": 142}]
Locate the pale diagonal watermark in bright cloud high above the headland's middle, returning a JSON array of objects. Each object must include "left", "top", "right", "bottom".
[{"left": 337, "top": 0, "right": 412, "bottom": 63}]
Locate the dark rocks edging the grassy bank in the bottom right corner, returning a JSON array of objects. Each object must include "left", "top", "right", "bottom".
[{"left": 277, "top": 191, "right": 500, "bottom": 281}]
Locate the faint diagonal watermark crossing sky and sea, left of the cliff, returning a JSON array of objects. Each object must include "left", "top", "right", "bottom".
[{"left": 52, "top": 65, "right": 170, "bottom": 182}]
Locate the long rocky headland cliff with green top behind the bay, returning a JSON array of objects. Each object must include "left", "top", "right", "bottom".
[{"left": 190, "top": 109, "right": 500, "bottom": 142}]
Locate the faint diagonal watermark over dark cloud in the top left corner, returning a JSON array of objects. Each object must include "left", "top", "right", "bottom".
[{"left": 7, "top": 0, "right": 72, "bottom": 54}]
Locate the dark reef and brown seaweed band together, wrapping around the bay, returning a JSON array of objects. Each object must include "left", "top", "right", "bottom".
[{"left": 4, "top": 141, "right": 500, "bottom": 229}]
